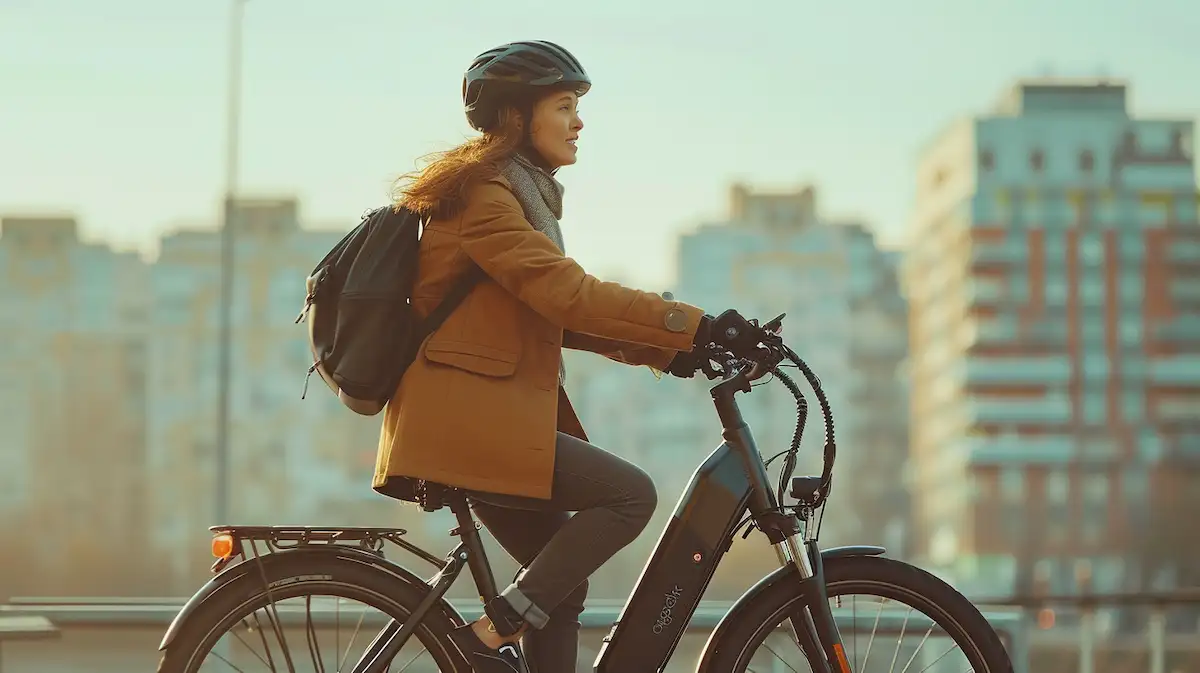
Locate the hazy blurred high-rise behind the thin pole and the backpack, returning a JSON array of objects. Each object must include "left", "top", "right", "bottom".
[{"left": 148, "top": 199, "right": 396, "bottom": 590}]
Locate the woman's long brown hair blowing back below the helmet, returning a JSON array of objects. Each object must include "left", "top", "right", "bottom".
[{"left": 392, "top": 107, "right": 524, "bottom": 218}]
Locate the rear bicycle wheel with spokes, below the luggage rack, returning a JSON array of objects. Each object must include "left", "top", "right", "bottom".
[{"left": 158, "top": 557, "right": 470, "bottom": 673}]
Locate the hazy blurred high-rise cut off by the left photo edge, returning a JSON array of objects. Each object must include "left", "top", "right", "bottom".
[{"left": 0, "top": 216, "right": 149, "bottom": 595}]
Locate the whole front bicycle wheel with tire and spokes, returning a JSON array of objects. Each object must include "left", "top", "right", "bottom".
[{"left": 701, "top": 557, "right": 1013, "bottom": 673}]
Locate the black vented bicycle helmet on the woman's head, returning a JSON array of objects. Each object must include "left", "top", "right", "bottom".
[{"left": 462, "top": 40, "right": 592, "bottom": 131}]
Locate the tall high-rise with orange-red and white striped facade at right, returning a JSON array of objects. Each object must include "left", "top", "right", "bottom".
[{"left": 905, "top": 79, "right": 1200, "bottom": 595}]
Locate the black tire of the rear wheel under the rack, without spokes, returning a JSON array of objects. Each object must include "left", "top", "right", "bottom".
[{"left": 158, "top": 557, "right": 472, "bottom": 673}]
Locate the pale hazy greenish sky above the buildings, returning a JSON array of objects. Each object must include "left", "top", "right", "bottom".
[{"left": 0, "top": 0, "right": 1200, "bottom": 289}]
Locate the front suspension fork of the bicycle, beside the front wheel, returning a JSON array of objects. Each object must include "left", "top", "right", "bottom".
[{"left": 774, "top": 534, "right": 852, "bottom": 673}]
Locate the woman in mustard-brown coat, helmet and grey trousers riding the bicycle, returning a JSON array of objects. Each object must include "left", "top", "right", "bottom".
[{"left": 374, "top": 41, "right": 744, "bottom": 673}]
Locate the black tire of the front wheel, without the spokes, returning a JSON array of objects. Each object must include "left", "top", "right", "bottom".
[{"left": 704, "top": 557, "right": 1013, "bottom": 673}]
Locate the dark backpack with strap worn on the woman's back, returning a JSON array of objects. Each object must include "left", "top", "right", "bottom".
[{"left": 296, "top": 206, "right": 484, "bottom": 416}]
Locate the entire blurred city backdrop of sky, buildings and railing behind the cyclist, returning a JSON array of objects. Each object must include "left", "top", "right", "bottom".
[{"left": 0, "top": 0, "right": 1200, "bottom": 673}]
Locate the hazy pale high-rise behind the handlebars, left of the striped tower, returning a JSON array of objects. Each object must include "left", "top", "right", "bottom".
[{"left": 678, "top": 185, "right": 907, "bottom": 555}]
